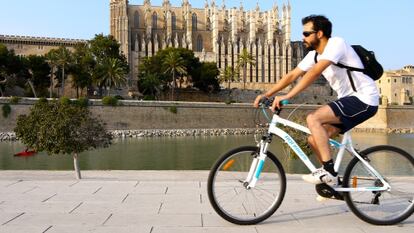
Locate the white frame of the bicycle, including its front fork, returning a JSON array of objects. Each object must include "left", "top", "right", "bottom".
[{"left": 245, "top": 110, "right": 391, "bottom": 192}]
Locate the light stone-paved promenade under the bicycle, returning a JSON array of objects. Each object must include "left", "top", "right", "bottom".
[{"left": 0, "top": 171, "right": 414, "bottom": 233}]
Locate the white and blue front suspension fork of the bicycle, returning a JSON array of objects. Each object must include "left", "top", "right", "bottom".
[{"left": 243, "top": 136, "right": 271, "bottom": 189}]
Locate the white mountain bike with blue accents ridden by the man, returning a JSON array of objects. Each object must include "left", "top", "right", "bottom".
[{"left": 207, "top": 99, "right": 414, "bottom": 225}]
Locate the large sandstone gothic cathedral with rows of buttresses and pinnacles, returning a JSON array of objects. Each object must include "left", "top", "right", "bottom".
[{"left": 110, "top": 0, "right": 304, "bottom": 89}]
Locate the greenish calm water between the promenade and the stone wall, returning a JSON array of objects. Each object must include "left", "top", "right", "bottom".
[{"left": 0, "top": 133, "right": 414, "bottom": 173}]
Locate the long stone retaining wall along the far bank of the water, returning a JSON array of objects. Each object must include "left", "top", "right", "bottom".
[{"left": 0, "top": 98, "right": 414, "bottom": 135}]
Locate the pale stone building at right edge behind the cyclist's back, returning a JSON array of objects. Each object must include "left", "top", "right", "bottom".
[{"left": 377, "top": 65, "right": 414, "bottom": 105}]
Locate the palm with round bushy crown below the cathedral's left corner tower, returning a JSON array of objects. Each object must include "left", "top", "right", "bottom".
[{"left": 97, "top": 57, "right": 127, "bottom": 95}]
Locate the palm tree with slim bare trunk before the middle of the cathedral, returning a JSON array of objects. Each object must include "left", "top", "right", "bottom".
[{"left": 163, "top": 51, "right": 187, "bottom": 100}]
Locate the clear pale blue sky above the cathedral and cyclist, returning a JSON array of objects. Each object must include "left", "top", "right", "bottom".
[{"left": 0, "top": 0, "right": 414, "bottom": 70}]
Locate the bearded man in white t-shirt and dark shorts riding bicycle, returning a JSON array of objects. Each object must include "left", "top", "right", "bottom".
[{"left": 254, "top": 15, "right": 379, "bottom": 185}]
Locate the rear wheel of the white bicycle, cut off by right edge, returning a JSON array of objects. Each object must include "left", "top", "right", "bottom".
[{"left": 344, "top": 146, "right": 414, "bottom": 225}]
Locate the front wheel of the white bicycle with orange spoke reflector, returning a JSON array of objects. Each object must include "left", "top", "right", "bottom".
[{"left": 207, "top": 146, "right": 286, "bottom": 225}]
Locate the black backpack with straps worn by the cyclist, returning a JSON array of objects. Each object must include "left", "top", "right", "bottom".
[{"left": 315, "top": 45, "right": 384, "bottom": 92}]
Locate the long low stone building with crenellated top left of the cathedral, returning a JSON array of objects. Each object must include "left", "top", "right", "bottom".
[{"left": 0, "top": 35, "right": 88, "bottom": 56}]
